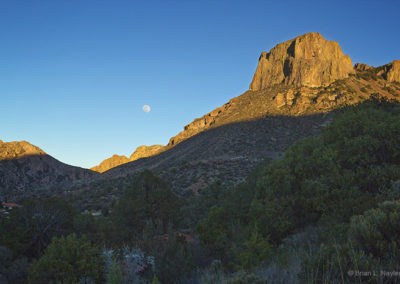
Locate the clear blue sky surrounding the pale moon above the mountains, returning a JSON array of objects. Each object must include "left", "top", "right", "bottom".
[{"left": 0, "top": 0, "right": 400, "bottom": 167}]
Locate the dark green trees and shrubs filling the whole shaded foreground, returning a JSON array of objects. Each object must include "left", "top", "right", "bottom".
[{"left": 0, "top": 97, "right": 400, "bottom": 283}]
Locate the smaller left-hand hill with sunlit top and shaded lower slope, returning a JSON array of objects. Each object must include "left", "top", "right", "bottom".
[{"left": 0, "top": 140, "right": 97, "bottom": 200}]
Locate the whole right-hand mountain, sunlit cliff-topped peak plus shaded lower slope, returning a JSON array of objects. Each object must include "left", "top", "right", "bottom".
[{"left": 86, "top": 33, "right": 400, "bottom": 193}]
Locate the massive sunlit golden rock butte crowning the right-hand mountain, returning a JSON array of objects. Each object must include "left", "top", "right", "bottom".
[{"left": 250, "top": 33, "right": 354, "bottom": 91}]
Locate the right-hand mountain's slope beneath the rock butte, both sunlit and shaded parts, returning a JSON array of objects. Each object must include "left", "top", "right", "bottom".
[{"left": 99, "top": 73, "right": 400, "bottom": 193}]
